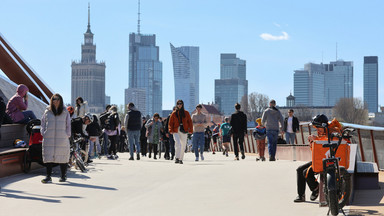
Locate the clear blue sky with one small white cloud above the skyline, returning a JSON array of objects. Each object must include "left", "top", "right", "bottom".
[{"left": 0, "top": 0, "right": 384, "bottom": 109}]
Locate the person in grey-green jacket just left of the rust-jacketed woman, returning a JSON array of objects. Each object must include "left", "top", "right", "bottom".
[{"left": 145, "top": 113, "right": 163, "bottom": 160}]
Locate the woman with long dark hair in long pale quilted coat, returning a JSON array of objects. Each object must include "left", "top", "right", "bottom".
[{"left": 41, "top": 94, "right": 71, "bottom": 183}]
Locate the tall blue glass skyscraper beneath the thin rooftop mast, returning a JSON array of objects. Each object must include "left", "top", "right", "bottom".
[{"left": 125, "top": 33, "right": 163, "bottom": 116}]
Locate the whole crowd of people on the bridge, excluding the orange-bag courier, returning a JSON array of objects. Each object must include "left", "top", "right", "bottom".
[{"left": 0, "top": 84, "right": 306, "bottom": 183}]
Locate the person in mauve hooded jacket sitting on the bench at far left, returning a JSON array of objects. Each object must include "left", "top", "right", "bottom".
[{"left": 5, "top": 84, "right": 36, "bottom": 124}]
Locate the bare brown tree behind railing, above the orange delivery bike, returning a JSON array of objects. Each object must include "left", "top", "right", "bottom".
[{"left": 333, "top": 98, "right": 368, "bottom": 125}]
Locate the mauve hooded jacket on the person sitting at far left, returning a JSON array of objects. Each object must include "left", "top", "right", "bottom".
[{"left": 6, "top": 84, "right": 29, "bottom": 122}]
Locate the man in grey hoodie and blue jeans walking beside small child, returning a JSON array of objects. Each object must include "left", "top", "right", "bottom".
[{"left": 261, "top": 100, "right": 284, "bottom": 161}]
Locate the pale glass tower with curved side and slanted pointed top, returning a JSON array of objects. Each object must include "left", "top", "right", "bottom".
[{"left": 170, "top": 44, "right": 199, "bottom": 112}]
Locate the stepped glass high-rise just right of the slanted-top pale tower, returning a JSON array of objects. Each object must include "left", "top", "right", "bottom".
[{"left": 215, "top": 54, "right": 248, "bottom": 115}]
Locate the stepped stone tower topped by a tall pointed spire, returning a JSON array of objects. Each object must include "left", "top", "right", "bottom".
[{"left": 71, "top": 6, "right": 105, "bottom": 113}]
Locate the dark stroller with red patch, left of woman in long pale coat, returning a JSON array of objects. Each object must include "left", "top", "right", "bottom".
[{"left": 23, "top": 119, "right": 44, "bottom": 173}]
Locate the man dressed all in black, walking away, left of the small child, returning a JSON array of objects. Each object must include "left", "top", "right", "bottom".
[{"left": 230, "top": 103, "right": 247, "bottom": 160}]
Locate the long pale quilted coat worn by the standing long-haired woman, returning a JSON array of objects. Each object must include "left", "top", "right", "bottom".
[{"left": 40, "top": 107, "right": 71, "bottom": 164}]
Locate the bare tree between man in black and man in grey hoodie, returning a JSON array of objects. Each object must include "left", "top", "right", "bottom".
[{"left": 247, "top": 92, "right": 269, "bottom": 121}]
